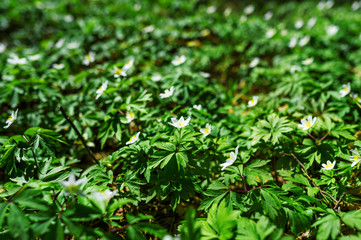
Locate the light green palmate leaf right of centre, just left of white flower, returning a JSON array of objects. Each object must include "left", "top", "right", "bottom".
[{"left": 250, "top": 113, "right": 293, "bottom": 145}]
